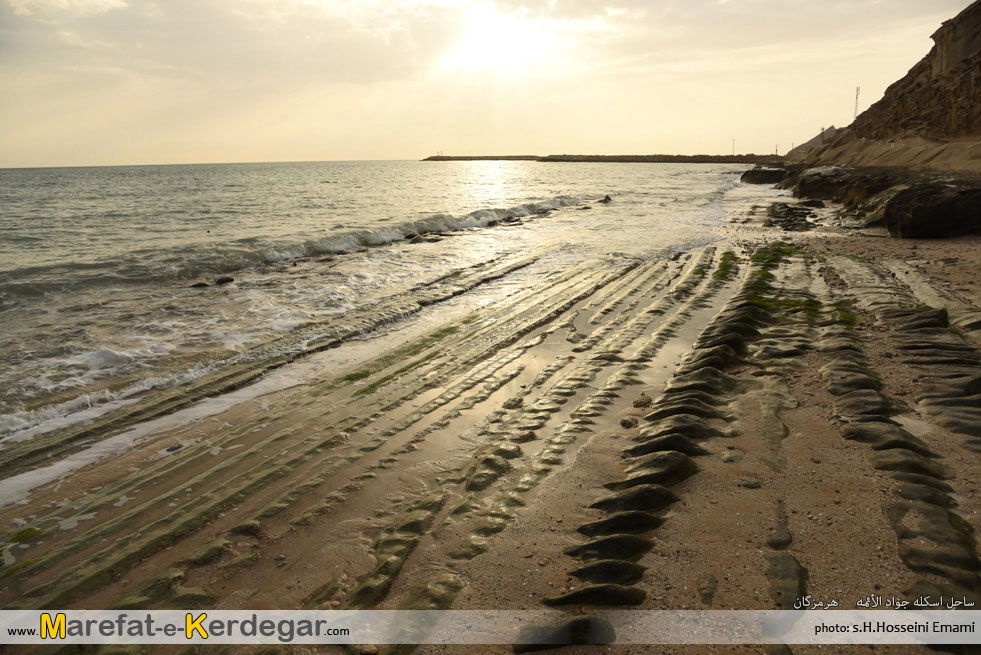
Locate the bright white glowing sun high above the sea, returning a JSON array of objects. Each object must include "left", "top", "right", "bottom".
[{"left": 439, "top": 4, "right": 556, "bottom": 75}]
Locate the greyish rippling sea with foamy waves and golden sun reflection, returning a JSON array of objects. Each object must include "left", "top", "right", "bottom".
[{"left": 0, "top": 161, "right": 774, "bottom": 448}]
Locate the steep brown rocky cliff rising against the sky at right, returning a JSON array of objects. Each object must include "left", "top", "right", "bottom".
[{"left": 798, "top": 0, "right": 981, "bottom": 171}]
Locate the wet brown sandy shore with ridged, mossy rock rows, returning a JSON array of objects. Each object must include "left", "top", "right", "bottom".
[{"left": 0, "top": 197, "right": 981, "bottom": 653}]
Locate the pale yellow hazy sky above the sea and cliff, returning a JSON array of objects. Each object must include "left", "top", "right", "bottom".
[{"left": 0, "top": 0, "right": 970, "bottom": 167}]
